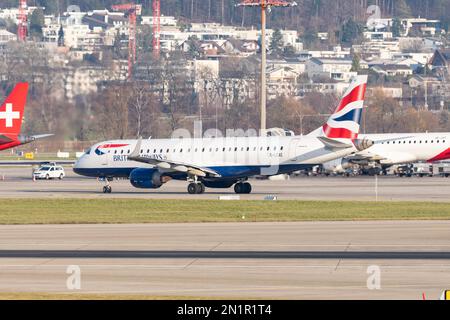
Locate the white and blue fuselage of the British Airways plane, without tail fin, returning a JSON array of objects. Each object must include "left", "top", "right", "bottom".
[{"left": 74, "top": 136, "right": 356, "bottom": 179}]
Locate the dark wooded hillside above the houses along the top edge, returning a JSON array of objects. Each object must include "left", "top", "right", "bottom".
[{"left": 0, "top": 0, "right": 450, "bottom": 31}]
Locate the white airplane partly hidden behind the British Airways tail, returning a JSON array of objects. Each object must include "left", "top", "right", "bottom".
[{"left": 311, "top": 132, "right": 450, "bottom": 173}]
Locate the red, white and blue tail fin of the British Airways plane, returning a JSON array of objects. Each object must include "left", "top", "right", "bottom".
[{"left": 310, "top": 76, "right": 367, "bottom": 140}]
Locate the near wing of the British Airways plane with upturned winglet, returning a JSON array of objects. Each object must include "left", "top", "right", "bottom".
[{"left": 128, "top": 139, "right": 221, "bottom": 178}]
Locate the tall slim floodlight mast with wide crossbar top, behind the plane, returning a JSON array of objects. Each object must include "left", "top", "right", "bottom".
[{"left": 236, "top": 0, "right": 297, "bottom": 135}]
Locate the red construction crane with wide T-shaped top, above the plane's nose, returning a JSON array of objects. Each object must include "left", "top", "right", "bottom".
[{"left": 111, "top": 3, "right": 142, "bottom": 79}]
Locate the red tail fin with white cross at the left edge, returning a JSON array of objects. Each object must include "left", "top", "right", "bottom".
[{"left": 0, "top": 82, "right": 28, "bottom": 135}]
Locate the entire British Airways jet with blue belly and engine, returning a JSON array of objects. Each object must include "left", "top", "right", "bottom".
[{"left": 74, "top": 76, "right": 373, "bottom": 194}]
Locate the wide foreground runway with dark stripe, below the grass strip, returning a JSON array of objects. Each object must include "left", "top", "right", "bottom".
[{"left": 0, "top": 221, "right": 450, "bottom": 299}]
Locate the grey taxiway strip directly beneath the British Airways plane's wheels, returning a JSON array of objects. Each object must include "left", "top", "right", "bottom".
[{"left": 0, "top": 167, "right": 450, "bottom": 202}]
